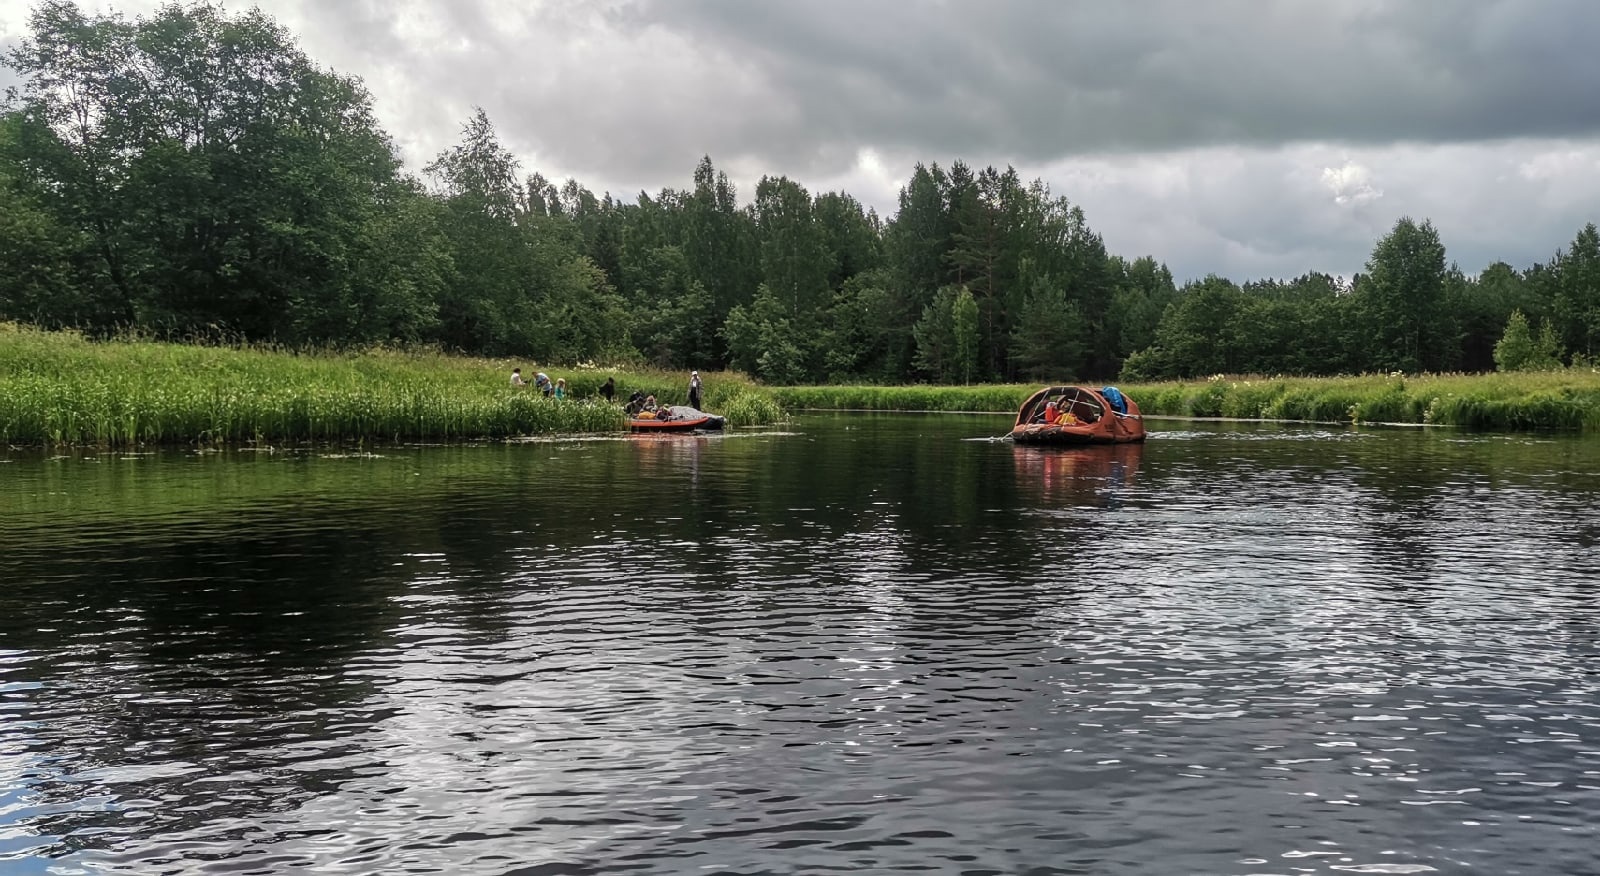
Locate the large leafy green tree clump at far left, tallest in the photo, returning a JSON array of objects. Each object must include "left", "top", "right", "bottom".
[{"left": 8, "top": 0, "right": 412, "bottom": 340}]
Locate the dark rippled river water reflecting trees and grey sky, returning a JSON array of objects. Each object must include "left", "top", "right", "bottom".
[{"left": 0, "top": 414, "right": 1600, "bottom": 876}]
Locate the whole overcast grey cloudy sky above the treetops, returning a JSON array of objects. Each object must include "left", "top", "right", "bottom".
[{"left": 0, "top": 0, "right": 1600, "bottom": 280}]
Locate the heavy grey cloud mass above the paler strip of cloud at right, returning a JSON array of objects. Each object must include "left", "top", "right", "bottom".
[{"left": 100, "top": 0, "right": 1600, "bottom": 190}]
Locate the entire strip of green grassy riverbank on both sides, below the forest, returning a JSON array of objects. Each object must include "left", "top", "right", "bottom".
[{"left": 0, "top": 325, "right": 1600, "bottom": 448}]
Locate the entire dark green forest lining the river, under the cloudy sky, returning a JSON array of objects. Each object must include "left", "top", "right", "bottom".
[{"left": 0, "top": 0, "right": 1600, "bottom": 384}]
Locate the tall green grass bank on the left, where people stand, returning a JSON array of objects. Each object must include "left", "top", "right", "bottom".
[{"left": 0, "top": 325, "right": 779, "bottom": 446}]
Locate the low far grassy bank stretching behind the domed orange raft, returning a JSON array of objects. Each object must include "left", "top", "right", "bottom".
[{"left": 771, "top": 371, "right": 1600, "bottom": 432}]
